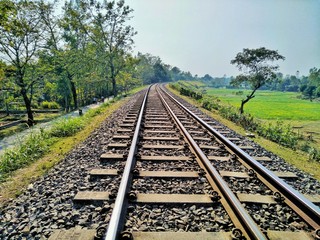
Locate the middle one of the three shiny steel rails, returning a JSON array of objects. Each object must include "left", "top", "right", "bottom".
[{"left": 158, "top": 86, "right": 267, "bottom": 240}]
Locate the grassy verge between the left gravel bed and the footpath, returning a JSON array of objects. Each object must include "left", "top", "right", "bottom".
[{"left": 0, "top": 87, "right": 144, "bottom": 202}]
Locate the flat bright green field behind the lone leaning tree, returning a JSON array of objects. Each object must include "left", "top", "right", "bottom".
[{"left": 207, "top": 88, "right": 320, "bottom": 121}]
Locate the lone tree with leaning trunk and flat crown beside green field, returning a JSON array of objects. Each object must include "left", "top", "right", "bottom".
[{"left": 230, "top": 47, "right": 285, "bottom": 114}]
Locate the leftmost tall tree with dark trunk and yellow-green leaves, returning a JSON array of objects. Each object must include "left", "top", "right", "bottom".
[{"left": 0, "top": 0, "right": 48, "bottom": 126}]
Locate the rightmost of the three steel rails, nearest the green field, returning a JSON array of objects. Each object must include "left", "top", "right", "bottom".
[{"left": 162, "top": 85, "right": 320, "bottom": 231}]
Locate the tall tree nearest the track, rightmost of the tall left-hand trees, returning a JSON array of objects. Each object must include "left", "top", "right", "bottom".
[{"left": 78, "top": 0, "right": 136, "bottom": 96}]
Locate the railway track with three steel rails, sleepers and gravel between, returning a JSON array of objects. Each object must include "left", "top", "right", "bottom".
[{"left": 1, "top": 85, "right": 320, "bottom": 240}]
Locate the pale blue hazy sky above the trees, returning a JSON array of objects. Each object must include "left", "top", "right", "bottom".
[{"left": 125, "top": 0, "right": 320, "bottom": 77}]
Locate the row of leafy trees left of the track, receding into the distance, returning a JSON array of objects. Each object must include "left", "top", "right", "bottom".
[{"left": 0, "top": 0, "right": 193, "bottom": 126}]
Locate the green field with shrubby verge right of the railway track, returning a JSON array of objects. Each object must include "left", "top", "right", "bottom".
[{"left": 170, "top": 82, "right": 320, "bottom": 162}]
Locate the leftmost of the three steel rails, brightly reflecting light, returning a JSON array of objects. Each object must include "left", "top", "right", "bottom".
[{"left": 104, "top": 86, "right": 151, "bottom": 240}]
